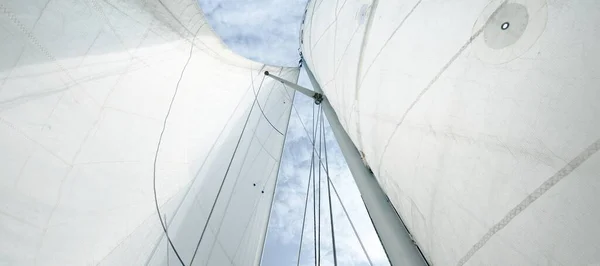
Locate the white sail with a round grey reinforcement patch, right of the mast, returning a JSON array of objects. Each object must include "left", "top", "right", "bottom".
[{"left": 302, "top": 0, "right": 600, "bottom": 265}]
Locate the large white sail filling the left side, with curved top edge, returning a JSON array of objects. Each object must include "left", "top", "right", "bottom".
[{"left": 0, "top": 0, "right": 298, "bottom": 265}]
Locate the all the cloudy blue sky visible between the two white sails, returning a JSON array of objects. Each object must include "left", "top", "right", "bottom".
[{"left": 199, "top": 0, "right": 389, "bottom": 266}]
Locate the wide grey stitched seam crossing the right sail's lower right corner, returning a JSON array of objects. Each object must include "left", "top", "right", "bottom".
[{"left": 456, "top": 139, "right": 600, "bottom": 266}]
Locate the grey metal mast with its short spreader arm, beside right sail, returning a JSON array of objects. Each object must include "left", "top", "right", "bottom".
[{"left": 265, "top": 67, "right": 427, "bottom": 266}]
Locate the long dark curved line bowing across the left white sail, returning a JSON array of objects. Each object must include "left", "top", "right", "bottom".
[{"left": 152, "top": 21, "right": 200, "bottom": 266}]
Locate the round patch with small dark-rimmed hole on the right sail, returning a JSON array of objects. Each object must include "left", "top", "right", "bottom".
[{"left": 473, "top": 0, "right": 548, "bottom": 64}]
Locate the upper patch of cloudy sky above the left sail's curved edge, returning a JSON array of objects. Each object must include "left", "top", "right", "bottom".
[{"left": 199, "top": 0, "right": 307, "bottom": 66}]
